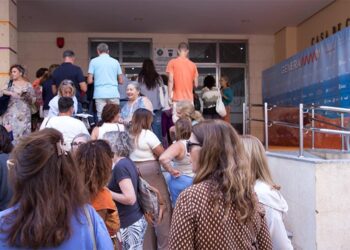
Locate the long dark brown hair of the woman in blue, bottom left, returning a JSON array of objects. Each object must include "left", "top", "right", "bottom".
[{"left": 1, "top": 128, "right": 87, "bottom": 249}]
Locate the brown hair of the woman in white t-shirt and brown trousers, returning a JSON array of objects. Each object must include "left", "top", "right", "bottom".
[{"left": 130, "top": 108, "right": 153, "bottom": 145}]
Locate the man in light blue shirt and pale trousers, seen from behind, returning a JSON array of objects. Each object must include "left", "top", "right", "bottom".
[{"left": 87, "top": 43, "right": 123, "bottom": 120}]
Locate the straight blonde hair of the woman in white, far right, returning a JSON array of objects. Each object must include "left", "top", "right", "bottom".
[{"left": 241, "top": 135, "right": 280, "bottom": 190}]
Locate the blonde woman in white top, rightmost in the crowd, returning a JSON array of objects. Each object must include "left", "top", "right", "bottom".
[{"left": 242, "top": 135, "right": 293, "bottom": 250}]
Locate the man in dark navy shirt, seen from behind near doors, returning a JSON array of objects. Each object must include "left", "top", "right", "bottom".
[{"left": 52, "top": 50, "right": 87, "bottom": 113}]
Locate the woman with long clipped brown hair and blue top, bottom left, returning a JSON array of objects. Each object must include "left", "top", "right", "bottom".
[{"left": 0, "top": 128, "right": 113, "bottom": 250}]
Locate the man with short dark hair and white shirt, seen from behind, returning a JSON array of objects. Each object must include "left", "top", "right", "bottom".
[{"left": 40, "top": 97, "right": 89, "bottom": 151}]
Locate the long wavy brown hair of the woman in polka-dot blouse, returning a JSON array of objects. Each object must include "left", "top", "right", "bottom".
[{"left": 192, "top": 120, "right": 257, "bottom": 222}]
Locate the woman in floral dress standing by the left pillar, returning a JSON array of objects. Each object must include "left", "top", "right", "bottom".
[{"left": 0, "top": 64, "right": 35, "bottom": 144}]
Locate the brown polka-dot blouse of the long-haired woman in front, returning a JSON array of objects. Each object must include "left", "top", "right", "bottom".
[{"left": 170, "top": 181, "right": 269, "bottom": 250}]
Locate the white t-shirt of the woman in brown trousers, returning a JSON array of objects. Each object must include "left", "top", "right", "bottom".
[{"left": 130, "top": 129, "right": 160, "bottom": 161}]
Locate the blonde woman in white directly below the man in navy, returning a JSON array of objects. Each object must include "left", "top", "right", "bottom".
[{"left": 48, "top": 80, "right": 78, "bottom": 117}]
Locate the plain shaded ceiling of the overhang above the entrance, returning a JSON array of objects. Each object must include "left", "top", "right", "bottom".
[{"left": 18, "top": 0, "right": 333, "bottom": 34}]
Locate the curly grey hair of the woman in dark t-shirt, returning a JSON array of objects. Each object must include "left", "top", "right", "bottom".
[{"left": 103, "top": 131, "right": 134, "bottom": 157}]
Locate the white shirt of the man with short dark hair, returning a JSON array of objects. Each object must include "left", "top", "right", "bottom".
[{"left": 40, "top": 116, "right": 89, "bottom": 151}]
